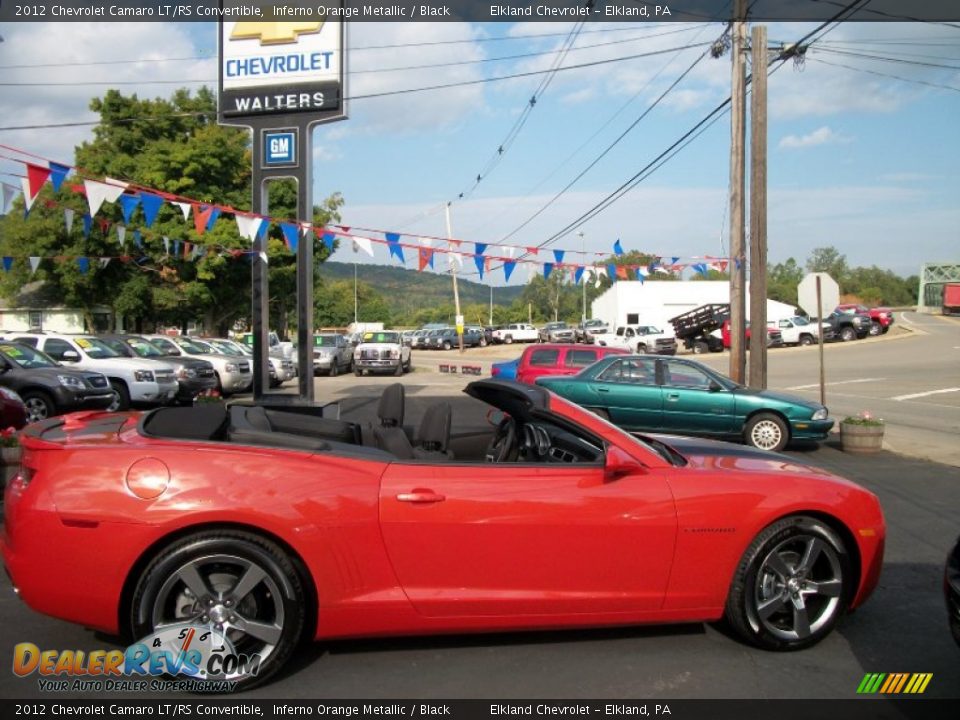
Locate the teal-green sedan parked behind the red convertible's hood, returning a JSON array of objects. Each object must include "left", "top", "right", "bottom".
[{"left": 537, "top": 355, "right": 833, "bottom": 451}]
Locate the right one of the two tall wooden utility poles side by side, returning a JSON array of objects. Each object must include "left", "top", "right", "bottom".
[{"left": 750, "top": 25, "right": 767, "bottom": 390}]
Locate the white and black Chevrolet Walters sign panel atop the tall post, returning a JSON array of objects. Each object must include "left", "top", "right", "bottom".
[{"left": 220, "top": 18, "right": 345, "bottom": 124}]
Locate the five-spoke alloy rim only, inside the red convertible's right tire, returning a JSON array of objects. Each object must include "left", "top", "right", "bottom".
[{"left": 750, "top": 534, "right": 843, "bottom": 641}]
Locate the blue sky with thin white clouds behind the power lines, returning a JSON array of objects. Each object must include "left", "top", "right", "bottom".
[{"left": 0, "top": 16, "right": 960, "bottom": 285}]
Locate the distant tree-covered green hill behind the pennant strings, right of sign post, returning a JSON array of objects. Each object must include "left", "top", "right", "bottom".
[{"left": 319, "top": 262, "right": 523, "bottom": 312}]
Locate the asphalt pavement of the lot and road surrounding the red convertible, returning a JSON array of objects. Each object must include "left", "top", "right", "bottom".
[{"left": 0, "top": 317, "right": 960, "bottom": 701}]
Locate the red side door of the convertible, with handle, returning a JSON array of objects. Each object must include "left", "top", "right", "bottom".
[{"left": 380, "top": 463, "right": 677, "bottom": 617}]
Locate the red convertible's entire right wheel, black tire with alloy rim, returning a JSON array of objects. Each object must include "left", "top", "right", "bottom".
[{"left": 725, "top": 516, "right": 856, "bottom": 650}]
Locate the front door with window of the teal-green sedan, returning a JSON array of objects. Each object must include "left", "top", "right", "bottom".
[{"left": 660, "top": 360, "right": 736, "bottom": 435}]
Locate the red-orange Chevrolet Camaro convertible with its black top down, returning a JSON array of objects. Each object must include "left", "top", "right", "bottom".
[{"left": 2, "top": 380, "right": 885, "bottom": 687}]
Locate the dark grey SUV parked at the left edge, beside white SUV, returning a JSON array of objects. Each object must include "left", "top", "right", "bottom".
[{"left": 0, "top": 341, "right": 114, "bottom": 423}]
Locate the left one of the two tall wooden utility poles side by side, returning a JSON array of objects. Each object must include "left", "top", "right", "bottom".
[{"left": 728, "top": 0, "right": 747, "bottom": 384}]
